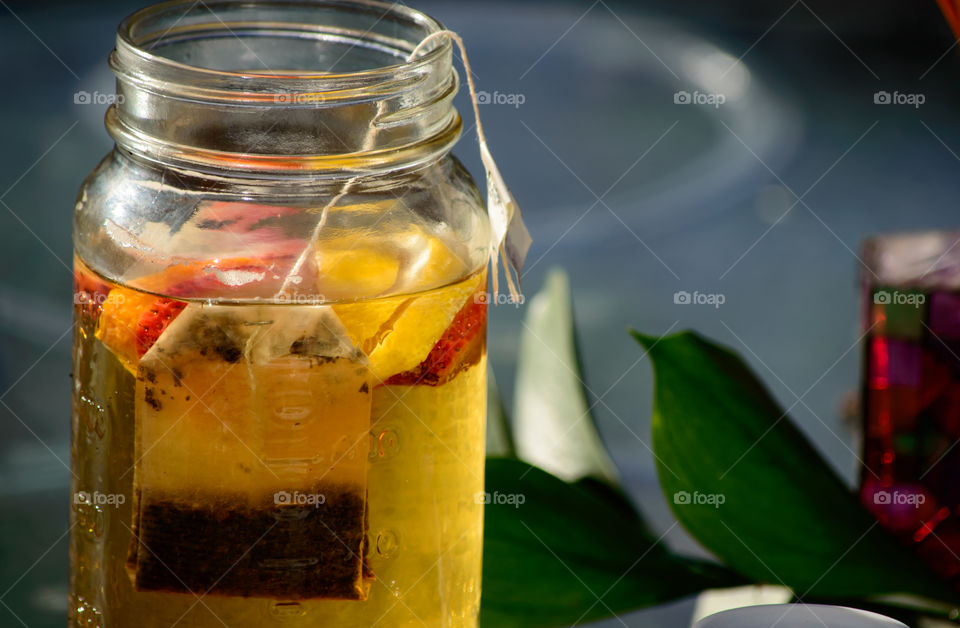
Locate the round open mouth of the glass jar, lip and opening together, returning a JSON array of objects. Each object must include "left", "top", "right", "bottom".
[{"left": 110, "top": 0, "right": 451, "bottom": 105}]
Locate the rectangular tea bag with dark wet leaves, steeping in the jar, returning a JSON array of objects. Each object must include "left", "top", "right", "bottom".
[{"left": 128, "top": 304, "right": 373, "bottom": 600}]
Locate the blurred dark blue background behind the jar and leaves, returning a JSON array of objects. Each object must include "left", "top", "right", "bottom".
[{"left": 0, "top": 0, "right": 960, "bottom": 628}]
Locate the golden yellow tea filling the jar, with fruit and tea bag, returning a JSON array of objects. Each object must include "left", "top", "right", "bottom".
[{"left": 70, "top": 260, "right": 486, "bottom": 628}]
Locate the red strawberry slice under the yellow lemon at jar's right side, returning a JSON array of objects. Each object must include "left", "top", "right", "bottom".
[{"left": 384, "top": 294, "right": 487, "bottom": 386}]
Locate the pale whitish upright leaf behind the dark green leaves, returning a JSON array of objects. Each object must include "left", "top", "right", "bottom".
[{"left": 513, "top": 269, "right": 618, "bottom": 484}]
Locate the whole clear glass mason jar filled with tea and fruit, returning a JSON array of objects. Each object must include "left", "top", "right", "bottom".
[{"left": 70, "top": 0, "right": 490, "bottom": 628}]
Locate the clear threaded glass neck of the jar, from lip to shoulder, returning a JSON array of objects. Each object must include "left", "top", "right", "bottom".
[{"left": 106, "top": 0, "right": 461, "bottom": 177}]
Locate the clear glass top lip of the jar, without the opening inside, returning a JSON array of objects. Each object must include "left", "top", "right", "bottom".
[{"left": 110, "top": 0, "right": 452, "bottom": 104}]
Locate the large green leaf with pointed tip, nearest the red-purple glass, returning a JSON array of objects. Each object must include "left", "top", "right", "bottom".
[{"left": 634, "top": 332, "right": 956, "bottom": 599}]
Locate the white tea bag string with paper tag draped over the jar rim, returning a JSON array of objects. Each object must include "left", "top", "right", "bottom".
[{"left": 274, "top": 30, "right": 531, "bottom": 303}]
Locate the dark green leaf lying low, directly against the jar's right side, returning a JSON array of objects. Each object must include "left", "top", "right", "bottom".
[{"left": 480, "top": 458, "right": 743, "bottom": 628}]
